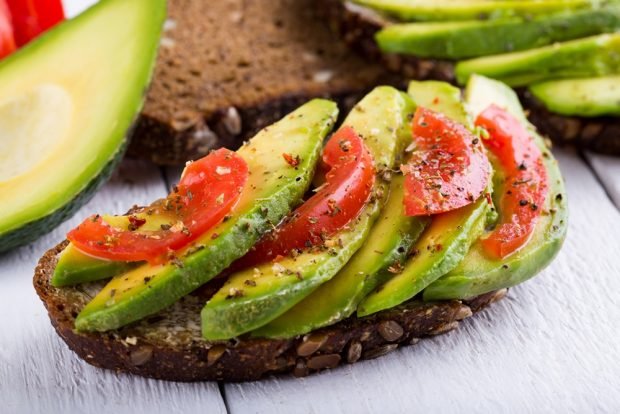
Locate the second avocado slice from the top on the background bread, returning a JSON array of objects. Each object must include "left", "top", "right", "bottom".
[{"left": 375, "top": 4, "right": 620, "bottom": 59}]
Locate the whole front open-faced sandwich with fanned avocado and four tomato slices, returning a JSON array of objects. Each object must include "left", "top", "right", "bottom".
[{"left": 34, "top": 76, "right": 567, "bottom": 381}]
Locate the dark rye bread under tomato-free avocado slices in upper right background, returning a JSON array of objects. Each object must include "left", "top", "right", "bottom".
[{"left": 317, "top": 0, "right": 620, "bottom": 155}]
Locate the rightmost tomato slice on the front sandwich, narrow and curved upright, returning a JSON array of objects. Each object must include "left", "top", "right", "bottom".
[{"left": 476, "top": 105, "right": 549, "bottom": 258}]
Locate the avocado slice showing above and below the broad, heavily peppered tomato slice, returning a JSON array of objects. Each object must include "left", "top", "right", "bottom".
[{"left": 357, "top": 81, "right": 491, "bottom": 316}]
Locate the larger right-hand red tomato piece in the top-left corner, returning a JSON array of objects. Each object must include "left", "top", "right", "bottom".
[{"left": 7, "top": 0, "right": 65, "bottom": 46}]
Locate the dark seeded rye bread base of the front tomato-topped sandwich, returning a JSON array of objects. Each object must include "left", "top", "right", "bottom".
[{"left": 34, "top": 241, "right": 507, "bottom": 381}]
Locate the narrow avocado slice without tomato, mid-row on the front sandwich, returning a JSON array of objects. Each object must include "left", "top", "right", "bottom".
[{"left": 252, "top": 175, "right": 430, "bottom": 338}]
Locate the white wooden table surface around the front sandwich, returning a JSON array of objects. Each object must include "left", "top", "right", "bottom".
[{"left": 0, "top": 0, "right": 620, "bottom": 414}]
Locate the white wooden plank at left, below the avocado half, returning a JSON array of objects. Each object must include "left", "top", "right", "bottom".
[{"left": 0, "top": 161, "right": 226, "bottom": 414}]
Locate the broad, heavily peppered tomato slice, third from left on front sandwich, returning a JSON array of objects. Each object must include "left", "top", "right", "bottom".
[{"left": 401, "top": 108, "right": 491, "bottom": 216}]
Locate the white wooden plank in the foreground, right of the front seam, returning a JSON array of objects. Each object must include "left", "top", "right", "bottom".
[{"left": 225, "top": 149, "right": 620, "bottom": 414}]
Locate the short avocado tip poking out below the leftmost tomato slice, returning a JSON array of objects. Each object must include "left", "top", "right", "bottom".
[{"left": 52, "top": 244, "right": 138, "bottom": 287}]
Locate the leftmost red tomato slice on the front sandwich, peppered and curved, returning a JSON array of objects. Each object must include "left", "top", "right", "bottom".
[{"left": 67, "top": 149, "right": 248, "bottom": 263}]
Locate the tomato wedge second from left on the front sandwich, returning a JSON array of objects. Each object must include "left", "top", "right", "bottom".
[{"left": 234, "top": 127, "right": 375, "bottom": 269}]
